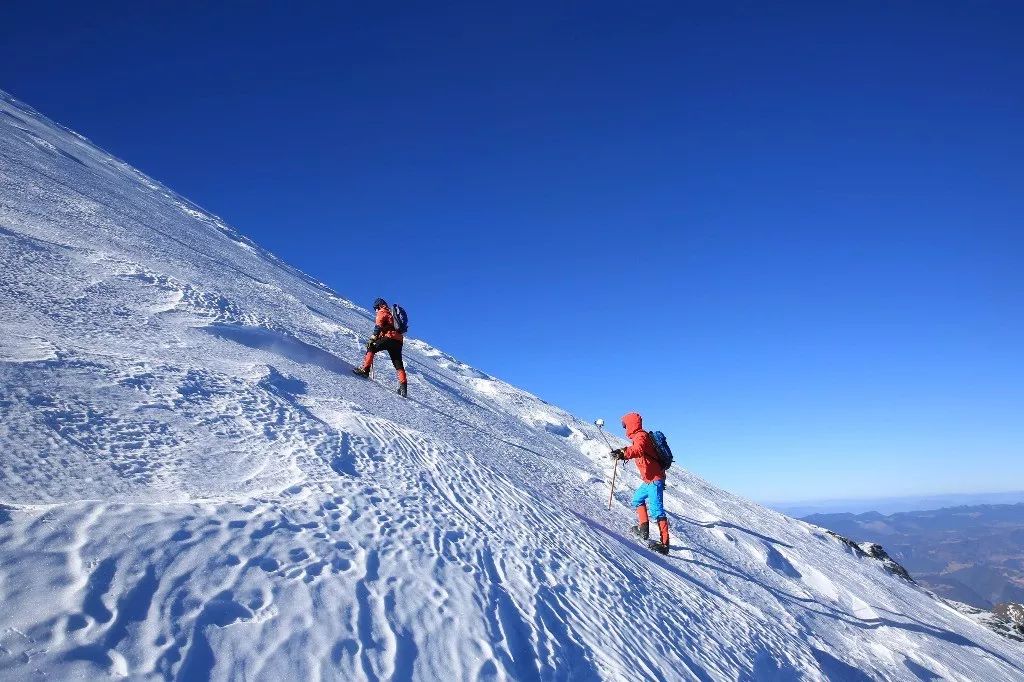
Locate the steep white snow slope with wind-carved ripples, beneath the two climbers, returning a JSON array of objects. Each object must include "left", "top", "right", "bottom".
[{"left": 0, "top": 94, "right": 1024, "bottom": 680}]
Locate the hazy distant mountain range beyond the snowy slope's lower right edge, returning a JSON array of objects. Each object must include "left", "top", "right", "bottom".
[{"left": 804, "top": 504, "right": 1024, "bottom": 609}]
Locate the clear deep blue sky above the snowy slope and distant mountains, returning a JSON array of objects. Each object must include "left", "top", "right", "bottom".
[{"left": 0, "top": 1, "right": 1024, "bottom": 501}]
